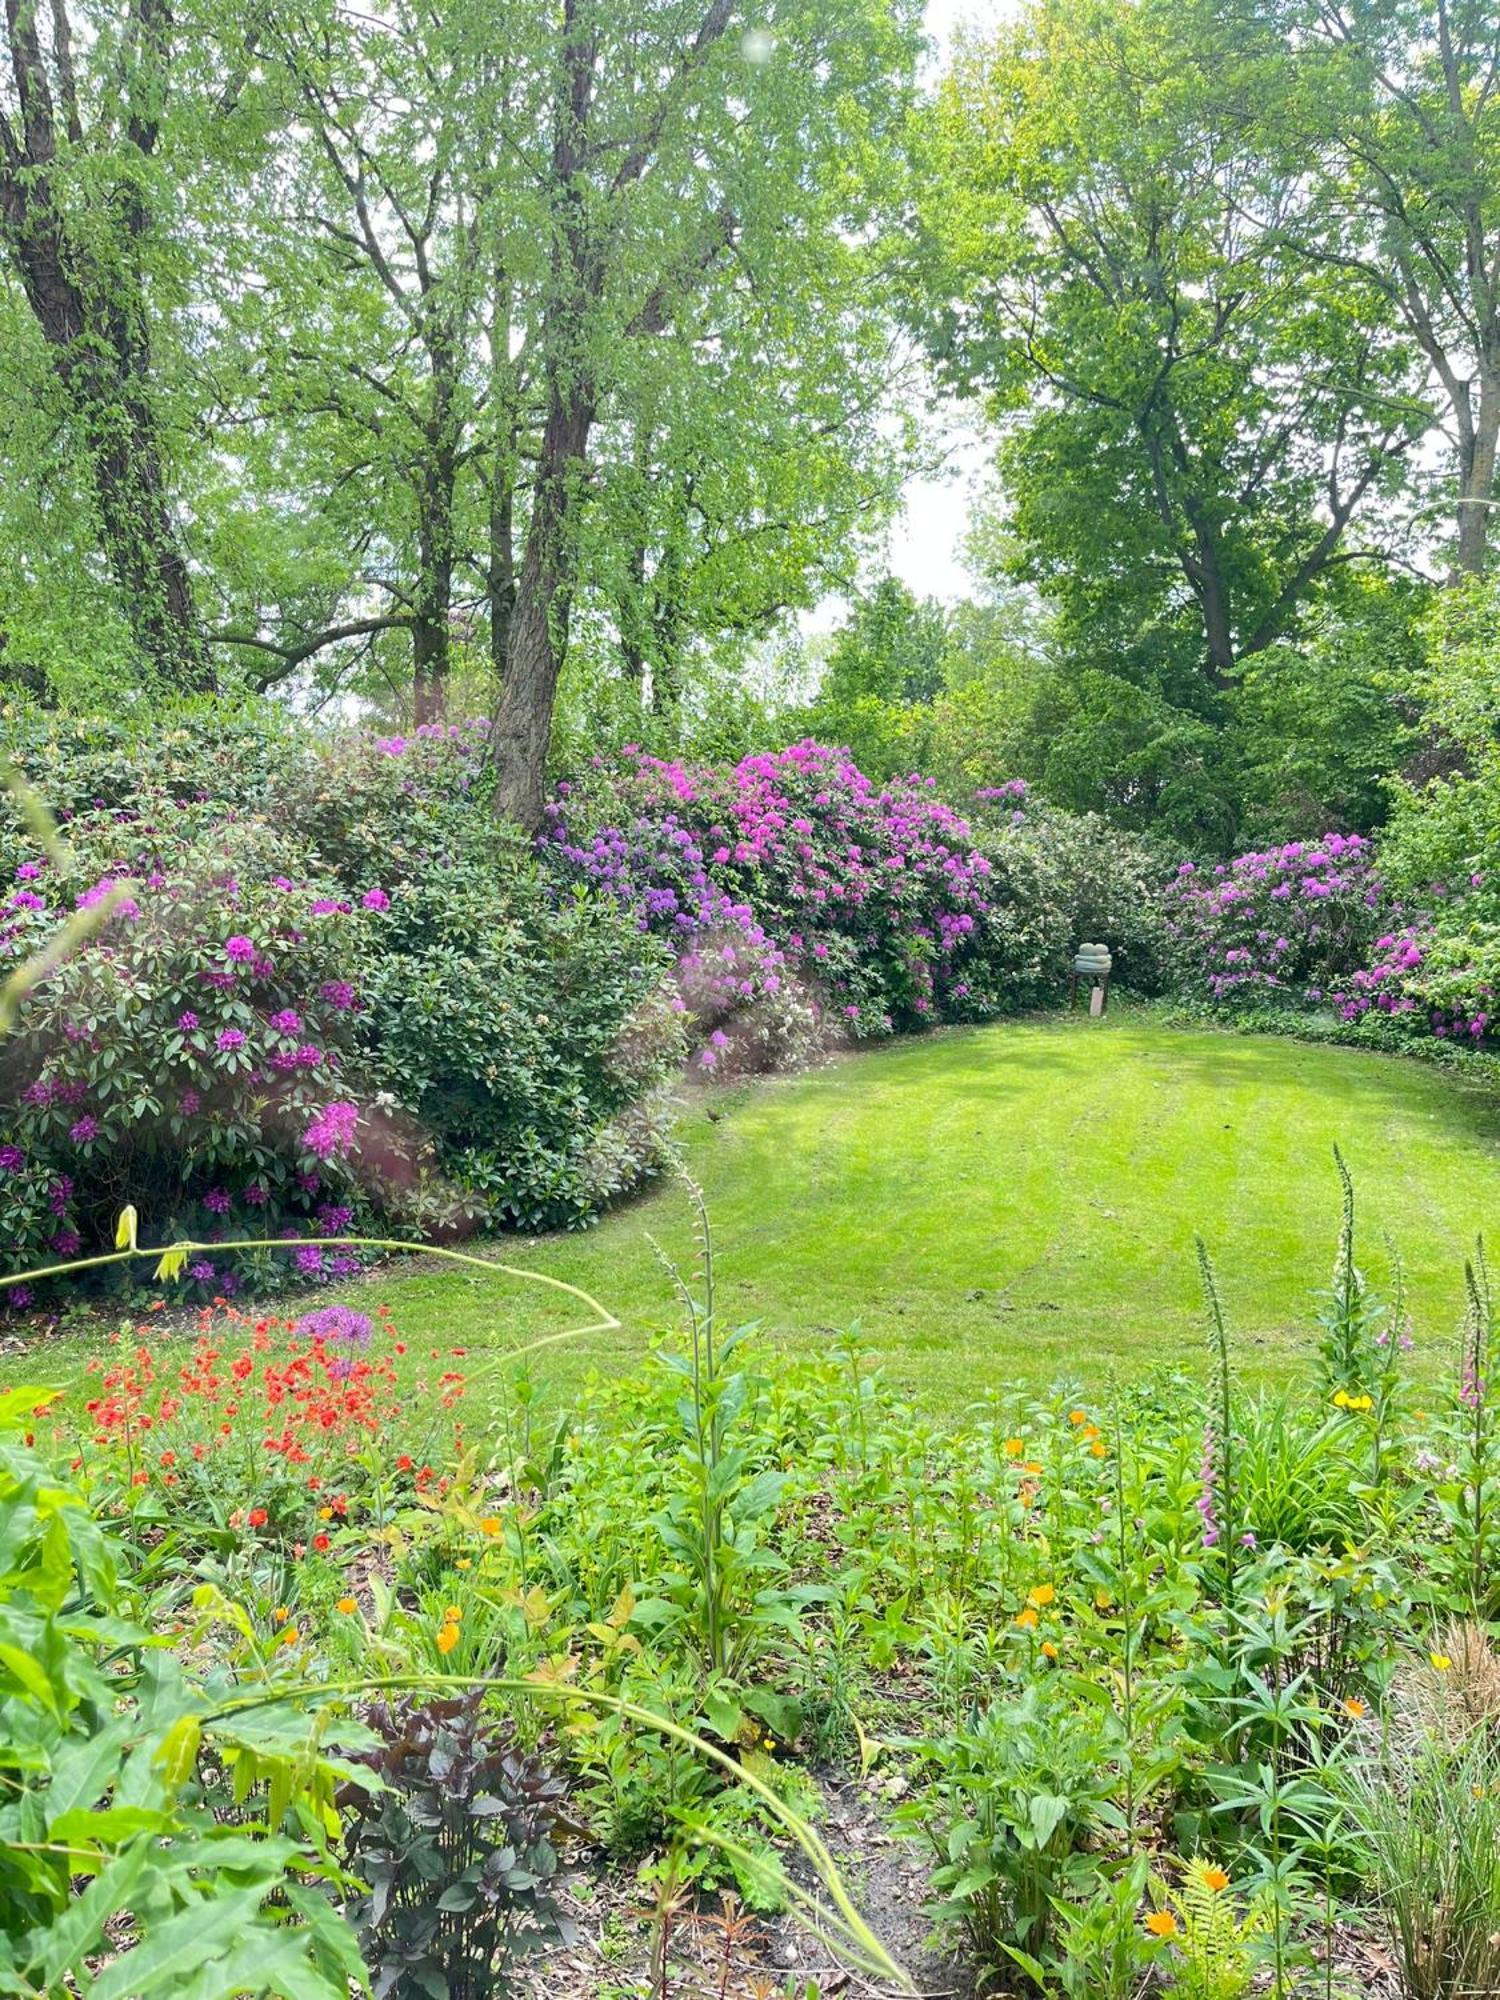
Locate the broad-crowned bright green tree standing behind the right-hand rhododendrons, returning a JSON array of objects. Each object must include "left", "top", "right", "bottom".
[{"left": 928, "top": 0, "right": 1428, "bottom": 700}]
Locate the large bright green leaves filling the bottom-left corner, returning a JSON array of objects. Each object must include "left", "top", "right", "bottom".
[{"left": 0, "top": 1390, "right": 368, "bottom": 2000}]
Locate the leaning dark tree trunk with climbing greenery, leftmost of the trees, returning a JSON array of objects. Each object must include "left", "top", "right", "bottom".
[{"left": 0, "top": 0, "right": 217, "bottom": 688}]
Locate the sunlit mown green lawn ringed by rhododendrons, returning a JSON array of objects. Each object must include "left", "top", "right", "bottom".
[{"left": 8, "top": 1010, "right": 1500, "bottom": 1412}]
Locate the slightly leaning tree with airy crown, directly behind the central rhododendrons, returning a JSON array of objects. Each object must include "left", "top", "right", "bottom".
[{"left": 492, "top": 0, "right": 916, "bottom": 826}]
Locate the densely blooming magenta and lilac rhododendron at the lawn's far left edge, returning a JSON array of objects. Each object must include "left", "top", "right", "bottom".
[{"left": 540, "top": 742, "right": 990, "bottom": 1062}]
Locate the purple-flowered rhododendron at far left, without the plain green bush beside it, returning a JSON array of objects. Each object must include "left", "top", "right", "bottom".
[{"left": 0, "top": 798, "right": 406, "bottom": 1296}]
